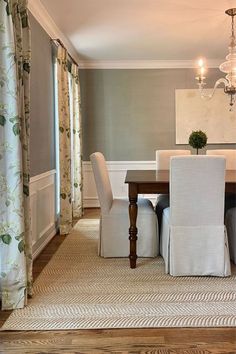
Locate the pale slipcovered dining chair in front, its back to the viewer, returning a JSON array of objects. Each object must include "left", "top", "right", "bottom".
[{"left": 160, "top": 156, "right": 231, "bottom": 277}]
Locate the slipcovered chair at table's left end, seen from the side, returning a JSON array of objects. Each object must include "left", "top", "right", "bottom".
[{"left": 90, "top": 152, "right": 159, "bottom": 257}]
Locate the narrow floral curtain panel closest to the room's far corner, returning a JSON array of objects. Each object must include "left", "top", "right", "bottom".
[{"left": 71, "top": 64, "right": 83, "bottom": 218}]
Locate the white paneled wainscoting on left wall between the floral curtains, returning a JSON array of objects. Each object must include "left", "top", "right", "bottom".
[{"left": 30, "top": 170, "right": 57, "bottom": 259}]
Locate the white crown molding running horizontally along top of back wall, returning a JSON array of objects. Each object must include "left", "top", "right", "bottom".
[{"left": 79, "top": 59, "right": 223, "bottom": 69}]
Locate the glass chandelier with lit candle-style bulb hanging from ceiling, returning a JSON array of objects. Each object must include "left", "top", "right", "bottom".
[{"left": 196, "top": 8, "right": 236, "bottom": 110}]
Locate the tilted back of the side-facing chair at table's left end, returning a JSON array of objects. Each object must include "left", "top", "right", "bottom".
[{"left": 90, "top": 152, "right": 113, "bottom": 214}]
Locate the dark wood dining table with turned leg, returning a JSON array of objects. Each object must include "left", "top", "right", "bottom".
[{"left": 125, "top": 170, "right": 236, "bottom": 268}]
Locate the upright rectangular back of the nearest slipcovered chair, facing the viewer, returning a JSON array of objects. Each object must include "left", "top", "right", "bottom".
[{"left": 170, "top": 155, "right": 225, "bottom": 226}]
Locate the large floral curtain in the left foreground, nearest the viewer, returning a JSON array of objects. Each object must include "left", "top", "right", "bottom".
[{"left": 0, "top": 0, "right": 32, "bottom": 310}]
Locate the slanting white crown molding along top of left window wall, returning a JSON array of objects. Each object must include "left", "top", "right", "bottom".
[{"left": 28, "top": 0, "right": 79, "bottom": 62}]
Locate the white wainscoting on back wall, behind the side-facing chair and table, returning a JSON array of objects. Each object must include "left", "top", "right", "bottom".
[{"left": 83, "top": 161, "right": 156, "bottom": 208}]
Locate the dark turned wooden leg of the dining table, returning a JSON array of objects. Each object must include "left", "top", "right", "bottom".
[{"left": 129, "top": 184, "right": 138, "bottom": 268}]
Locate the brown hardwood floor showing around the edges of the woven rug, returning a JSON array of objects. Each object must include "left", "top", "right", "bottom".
[{"left": 0, "top": 209, "right": 236, "bottom": 354}]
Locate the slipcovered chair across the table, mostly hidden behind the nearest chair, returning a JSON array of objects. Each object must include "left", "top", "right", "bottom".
[{"left": 155, "top": 150, "right": 191, "bottom": 232}]
